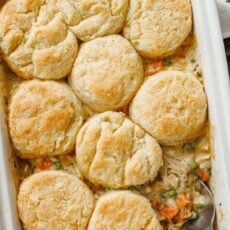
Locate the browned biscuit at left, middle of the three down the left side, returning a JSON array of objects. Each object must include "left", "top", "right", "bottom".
[{"left": 9, "top": 79, "right": 84, "bottom": 159}]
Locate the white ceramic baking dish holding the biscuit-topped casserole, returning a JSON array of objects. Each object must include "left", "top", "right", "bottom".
[{"left": 0, "top": 0, "right": 230, "bottom": 230}]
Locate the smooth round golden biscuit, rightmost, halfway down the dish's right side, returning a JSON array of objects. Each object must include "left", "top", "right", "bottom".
[{"left": 129, "top": 70, "right": 207, "bottom": 145}]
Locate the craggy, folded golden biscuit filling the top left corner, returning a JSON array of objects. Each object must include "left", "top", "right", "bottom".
[{"left": 0, "top": 0, "right": 78, "bottom": 80}]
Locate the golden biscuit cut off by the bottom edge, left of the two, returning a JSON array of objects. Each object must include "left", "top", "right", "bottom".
[{"left": 17, "top": 171, "right": 94, "bottom": 230}]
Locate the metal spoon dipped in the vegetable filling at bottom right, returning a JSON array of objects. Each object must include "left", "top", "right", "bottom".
[{"left": 181, "top": 181, "right": 215, "bottom": 230}]
